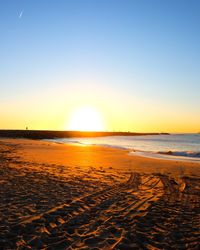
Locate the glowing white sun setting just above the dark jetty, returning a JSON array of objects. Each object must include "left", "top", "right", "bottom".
[{"left": 67, "top": 107, "right": 105, "bottom": 131}]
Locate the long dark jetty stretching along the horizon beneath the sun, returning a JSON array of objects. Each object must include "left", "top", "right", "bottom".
[{"left": 0, "top": 130, "right": 169, "bottom": 139}]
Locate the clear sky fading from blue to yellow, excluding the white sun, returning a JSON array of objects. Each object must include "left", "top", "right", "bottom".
[{"left": 0, "top": 0, "right": 200, "bottom": 132}]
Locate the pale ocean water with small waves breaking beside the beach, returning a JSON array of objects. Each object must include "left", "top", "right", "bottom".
[{"left": 54, "top": 134, "right": 200, "bottom": 162}]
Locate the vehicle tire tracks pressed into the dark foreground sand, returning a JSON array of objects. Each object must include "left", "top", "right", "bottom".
[{"left": 7, "top": 173, "right": 163, "bottom": 249}]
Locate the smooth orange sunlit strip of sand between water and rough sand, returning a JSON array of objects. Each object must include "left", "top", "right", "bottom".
[{"left": 0, "top": 138, "right": 200, "bottom": 174}]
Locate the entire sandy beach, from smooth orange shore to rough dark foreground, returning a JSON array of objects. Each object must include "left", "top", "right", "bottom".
[{"left": 0, "top": 139, "right": 200, "bottom": 250}]
